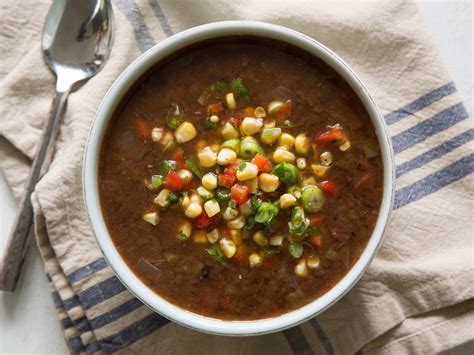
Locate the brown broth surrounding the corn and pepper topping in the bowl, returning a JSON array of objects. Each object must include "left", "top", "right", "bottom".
[{"left": 99, "top": 38, "right": 383, "bottom": 320}]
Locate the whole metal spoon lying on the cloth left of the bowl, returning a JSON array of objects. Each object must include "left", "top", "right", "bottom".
[{"left": 0, "top": 0, "right": 113, "bottom": 292}]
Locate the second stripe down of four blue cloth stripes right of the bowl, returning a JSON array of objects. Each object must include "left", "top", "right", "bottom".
[{"left": 392, "top": 103, "right": 469, "bottom": 154}]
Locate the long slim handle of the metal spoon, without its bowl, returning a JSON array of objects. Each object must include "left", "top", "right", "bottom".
[{"left": 0, "top": 88, "right": 70, "bottom": 292}]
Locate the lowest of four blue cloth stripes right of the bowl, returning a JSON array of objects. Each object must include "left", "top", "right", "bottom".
[{"left": 394, "top": 154, "right": 474, "bottom": 209}]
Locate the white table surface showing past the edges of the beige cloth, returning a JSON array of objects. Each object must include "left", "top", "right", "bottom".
[{"left": 0, "top": 0, "right": 474, "bottom": 354}]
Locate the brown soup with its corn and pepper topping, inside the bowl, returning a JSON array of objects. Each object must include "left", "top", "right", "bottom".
[{"left": 98, "top": 37, "right": 383, "bottom": 320}]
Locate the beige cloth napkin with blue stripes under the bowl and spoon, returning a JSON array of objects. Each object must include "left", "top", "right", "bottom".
[{"left": 0, "top": 0, "right": 474, "bottom": 354}]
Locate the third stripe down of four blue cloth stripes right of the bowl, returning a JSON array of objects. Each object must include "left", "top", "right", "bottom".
[{"left": 397, "top": 129, "right": 474, "bottom": 177}]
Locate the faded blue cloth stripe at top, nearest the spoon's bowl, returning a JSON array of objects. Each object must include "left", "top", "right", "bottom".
[{"left": 114, "top": 0, "right": 155, "bottom": 53}]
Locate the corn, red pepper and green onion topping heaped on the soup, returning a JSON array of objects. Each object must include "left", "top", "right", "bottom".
[{"left": 138, "top": 78, "right": 378, "bottom": 277}]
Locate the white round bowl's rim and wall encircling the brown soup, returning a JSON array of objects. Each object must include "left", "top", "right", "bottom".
[{"left": 83, "top": 21, "right": 395, "bottom": 336}]
